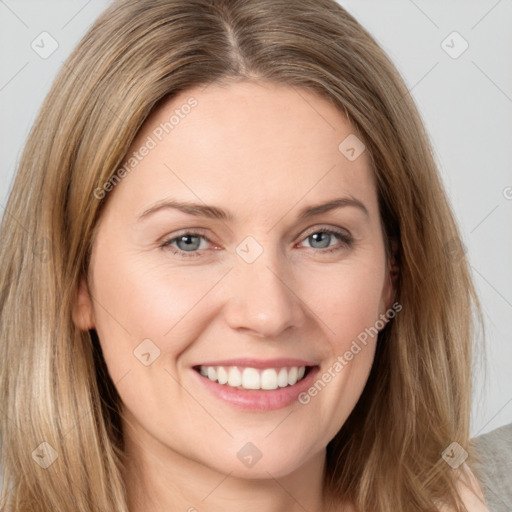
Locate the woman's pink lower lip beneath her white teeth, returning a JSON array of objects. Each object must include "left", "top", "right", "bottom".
[{"left": 192, "top": 366, "right": 319, "bottom": 411}]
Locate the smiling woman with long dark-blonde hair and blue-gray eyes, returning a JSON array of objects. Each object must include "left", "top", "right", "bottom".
[{"left": 0, "top": 0, "right": 486, "bottom": 512}]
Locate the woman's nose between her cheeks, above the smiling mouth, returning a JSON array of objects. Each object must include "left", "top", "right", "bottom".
[{"left": 225, "top": 251, "right": 306, "bottom": 338}]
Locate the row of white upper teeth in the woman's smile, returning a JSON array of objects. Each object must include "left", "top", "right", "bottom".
[{"left": 199, "top": 366, "right": 306, "bottom": 389}]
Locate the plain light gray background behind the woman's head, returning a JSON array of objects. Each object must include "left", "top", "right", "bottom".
[{"left": 0, "top": 0, "right": 512, "bottom": 435}]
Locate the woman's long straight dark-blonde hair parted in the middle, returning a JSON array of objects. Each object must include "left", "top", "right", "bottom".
[{"left": 0, "top": 0, "right": 479, "bottom": 512}]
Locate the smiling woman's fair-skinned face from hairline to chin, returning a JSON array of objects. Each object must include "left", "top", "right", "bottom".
[{"left": 75, "top": 82, "right": 393, "bottom": 478}]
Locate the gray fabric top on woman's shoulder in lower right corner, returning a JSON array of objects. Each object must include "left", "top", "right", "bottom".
[{"left": 472, "top": 423, "right": 512, "bottom": 512}]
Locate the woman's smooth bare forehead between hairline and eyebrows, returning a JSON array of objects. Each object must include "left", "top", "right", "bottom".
[{"left": 105, "top": 82, "right": 374, "bottom": 219}]
